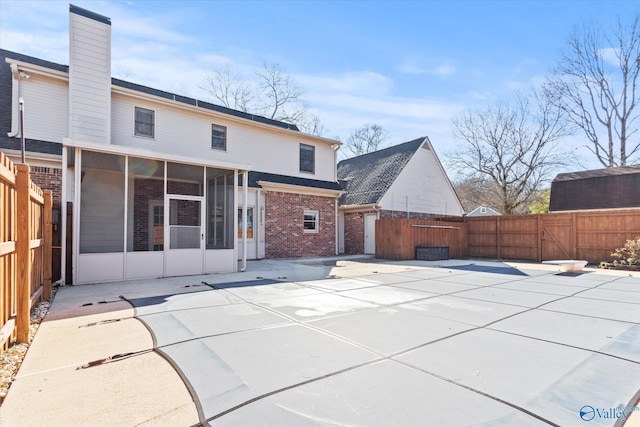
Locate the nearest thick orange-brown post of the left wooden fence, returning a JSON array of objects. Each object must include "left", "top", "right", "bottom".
[{"left": 16, "top": 164, "right": 31, "bottom": 343}]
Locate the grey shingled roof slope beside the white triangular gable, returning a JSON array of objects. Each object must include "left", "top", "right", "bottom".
[{"left": 338, "top": 137, "right": 427, "bottom": 205}]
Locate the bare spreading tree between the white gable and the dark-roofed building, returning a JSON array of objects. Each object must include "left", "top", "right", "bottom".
[{"left": 450, "top": 92, "right": 568, "bottom": 214}]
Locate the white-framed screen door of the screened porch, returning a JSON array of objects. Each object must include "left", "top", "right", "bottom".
[{"left": 164, "top": 196, "right": 204, "bottom": 276}]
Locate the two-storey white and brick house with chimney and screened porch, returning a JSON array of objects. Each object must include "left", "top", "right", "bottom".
[{"left": 0, "top": 6, "right": 342, "bottom": 284}]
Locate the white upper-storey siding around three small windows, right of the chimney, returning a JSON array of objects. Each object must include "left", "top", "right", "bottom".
[{"left": 111, "top": 95, "right": 335, "bottom": 181}]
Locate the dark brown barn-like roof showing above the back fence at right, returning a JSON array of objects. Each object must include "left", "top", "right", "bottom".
[{"left": 549, "top": 165, "right": 640, "bottom": 212}]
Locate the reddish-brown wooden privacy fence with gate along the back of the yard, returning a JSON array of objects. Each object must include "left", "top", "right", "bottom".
[{"left": 376, "top": 209, "right": 640, "bottom": 263}]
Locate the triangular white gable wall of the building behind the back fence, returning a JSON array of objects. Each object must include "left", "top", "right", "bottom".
[{"left": 380, "top": 148, "right": 464, "bottom": 216}]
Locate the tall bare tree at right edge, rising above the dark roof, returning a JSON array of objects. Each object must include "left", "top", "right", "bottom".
[{"left": 547, "top": 14, "right": 640, "bottom": 167}]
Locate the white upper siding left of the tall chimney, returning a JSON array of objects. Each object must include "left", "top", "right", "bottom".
[{"left": 20, "top": 73, "right": 69, "bottom": 143}]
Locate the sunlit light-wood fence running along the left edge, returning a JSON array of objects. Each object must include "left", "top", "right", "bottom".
[{"left": 0, "top": 153, "right": 52, "bottom": 353}]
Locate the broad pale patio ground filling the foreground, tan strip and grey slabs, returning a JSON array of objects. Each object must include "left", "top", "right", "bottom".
[{"left": 0, "top": 257, "right": 640, "bottom": 426}]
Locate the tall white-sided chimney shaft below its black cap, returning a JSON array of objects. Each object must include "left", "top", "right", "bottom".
[{"left": 69, "top": 13, "right": 111, "bottom": 144}]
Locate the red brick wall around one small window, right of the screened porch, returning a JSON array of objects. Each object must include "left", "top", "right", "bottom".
[{"left": 265, "top": 192, "right": 336, "bottom": 258}]
